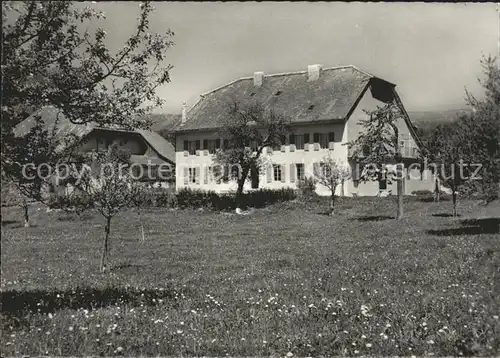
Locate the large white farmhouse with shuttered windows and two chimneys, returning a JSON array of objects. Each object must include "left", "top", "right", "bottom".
[{"left": 175, "top": 65, "right": 433, "bottom": 196}]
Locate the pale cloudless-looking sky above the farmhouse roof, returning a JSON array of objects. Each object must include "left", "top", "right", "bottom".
[{"left": 92, "top": 2, "right": 499, "bottom": 113}]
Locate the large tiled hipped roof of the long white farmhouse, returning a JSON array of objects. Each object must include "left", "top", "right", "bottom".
[{"left": 175, "top": 66, "right": 394, "bottom": 131}]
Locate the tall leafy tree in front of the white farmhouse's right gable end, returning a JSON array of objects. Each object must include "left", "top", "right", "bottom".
[{"left": 348, "top": 101, "right": 404, "bottom": 219}]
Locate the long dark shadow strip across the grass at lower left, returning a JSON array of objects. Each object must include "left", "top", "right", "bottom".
[{"left": 0, "top": 287, "right": 177, "bottom": 317}]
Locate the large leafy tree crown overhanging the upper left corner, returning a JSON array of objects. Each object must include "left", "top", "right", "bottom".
[{"left": 1, "top": 1, "right": 173, "bottom": 193}]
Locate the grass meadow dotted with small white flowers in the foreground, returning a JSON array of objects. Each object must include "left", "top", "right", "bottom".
[{"left": 0, "top": 198, "right": 500, "bottom": 357}]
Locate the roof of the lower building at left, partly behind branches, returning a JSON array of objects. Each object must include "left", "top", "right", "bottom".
[{"left": 14, "top": 106, "right": 175, "bottom": 163}]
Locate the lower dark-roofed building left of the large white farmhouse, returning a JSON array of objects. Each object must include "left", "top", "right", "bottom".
[{"left": 14, "top": 106, "right": 175, "bottom": 187}]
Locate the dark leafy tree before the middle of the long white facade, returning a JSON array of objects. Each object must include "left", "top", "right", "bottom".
[{"left": 215, "top": 102, "right": 290, "bottom": 207}]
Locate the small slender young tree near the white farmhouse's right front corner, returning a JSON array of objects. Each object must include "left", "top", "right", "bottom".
[{"left": 314, "top": 154, "right": 351, "bottom": 215}]
